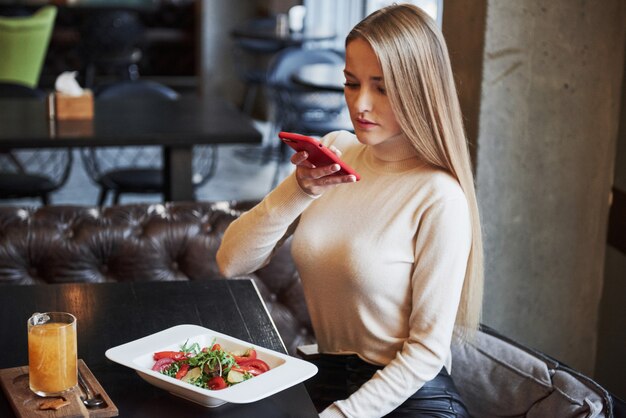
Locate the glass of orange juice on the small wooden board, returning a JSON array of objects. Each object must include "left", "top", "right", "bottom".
[{"left": 28, "top": 312, "right": 78, "bottom": 396}]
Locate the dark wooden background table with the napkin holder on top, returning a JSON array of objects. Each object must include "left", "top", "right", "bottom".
[{"left": 0, "top": 95, "right": 261, "bottom": 201}]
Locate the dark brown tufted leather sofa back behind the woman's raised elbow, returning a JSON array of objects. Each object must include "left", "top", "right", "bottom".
[{"left": 0, "top": 202, "right": 314, "bottom": 353}]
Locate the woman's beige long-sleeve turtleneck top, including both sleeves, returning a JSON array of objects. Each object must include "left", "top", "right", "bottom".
[{"left": 217, "top": 132, "right": 471, "bottom": 418}]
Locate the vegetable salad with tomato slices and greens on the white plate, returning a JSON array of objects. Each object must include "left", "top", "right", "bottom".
[{"left": 152, "top": 343, "right": 270, "bottom": 390}]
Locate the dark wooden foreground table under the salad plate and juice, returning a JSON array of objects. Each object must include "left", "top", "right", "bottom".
[{"left": 0, "top": 280, "right": 318, "bottom": 418}]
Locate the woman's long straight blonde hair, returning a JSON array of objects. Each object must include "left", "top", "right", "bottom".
[{"left": 346, "top": 4, "right": 483, "bottom": 340}]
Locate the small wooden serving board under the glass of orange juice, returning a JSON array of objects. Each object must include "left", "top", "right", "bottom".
[{"left": 0, "top": 359, "right": 119, "bottom": 418}]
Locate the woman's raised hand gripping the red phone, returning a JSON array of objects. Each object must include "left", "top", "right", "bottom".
[{"left": 291, "top": 146, "right": 356, "bottom": 196}]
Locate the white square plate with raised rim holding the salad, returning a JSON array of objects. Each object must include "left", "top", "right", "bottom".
[{"left": 105, "top": 325, "right": 317, "bottom": 407}]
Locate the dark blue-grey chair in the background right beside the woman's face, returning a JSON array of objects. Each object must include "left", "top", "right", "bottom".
[{"left": 267, "top": 48, "right": 353, "bottom": 186}]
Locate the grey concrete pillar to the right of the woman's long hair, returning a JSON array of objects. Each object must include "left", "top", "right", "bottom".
[{"left": 477, "top": 0, "right": 626, "bottom": 374}]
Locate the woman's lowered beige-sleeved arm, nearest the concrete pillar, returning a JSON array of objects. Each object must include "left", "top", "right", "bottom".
[{"left": 320, "top": 197, "right": 472, "bottom": 418}]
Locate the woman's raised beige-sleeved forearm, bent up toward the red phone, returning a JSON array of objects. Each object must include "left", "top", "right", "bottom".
[{"left": 217, "top": 174, "right": 315, "bottom": 277}]
